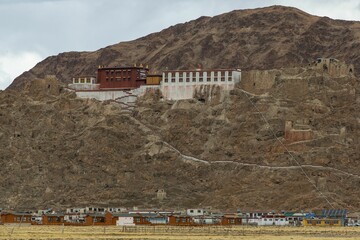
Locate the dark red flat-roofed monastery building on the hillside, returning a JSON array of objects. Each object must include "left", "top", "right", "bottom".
[{"left": 97, "top": 66, "right": 149, "bottom": 90}]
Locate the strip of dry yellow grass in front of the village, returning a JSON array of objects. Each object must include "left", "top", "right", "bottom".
[{"left": 0, "top": 225, "right": 360, "bottom": 240}]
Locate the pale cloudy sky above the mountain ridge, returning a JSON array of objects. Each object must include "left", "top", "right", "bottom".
[{"left": 0, "top": 0, "right": 360, "bottom": 90}]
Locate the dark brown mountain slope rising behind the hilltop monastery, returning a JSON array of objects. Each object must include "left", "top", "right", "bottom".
[{"left": 9, "top": 6, "right": 360, "bottom": 88}]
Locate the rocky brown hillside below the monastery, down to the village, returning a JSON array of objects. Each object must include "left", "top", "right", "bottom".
[{"left": 0, "top": 65, "right": 360, "bottom": 210}]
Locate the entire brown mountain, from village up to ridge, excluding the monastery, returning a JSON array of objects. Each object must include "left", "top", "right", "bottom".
[{"left": 0, "top": 6, "right": 360, "bottom": 210}]
